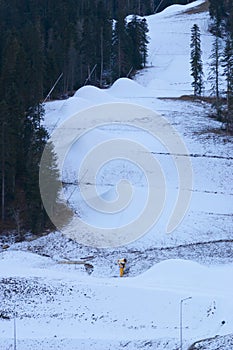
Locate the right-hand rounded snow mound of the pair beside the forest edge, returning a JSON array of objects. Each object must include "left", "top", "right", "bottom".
[{"left": 108, "top": 78, "right": 156, "bottom": 97}]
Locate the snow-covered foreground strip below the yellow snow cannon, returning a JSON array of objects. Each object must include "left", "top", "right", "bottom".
[{"left": 0, "top": 251, "right": 233, "bottom": 350}]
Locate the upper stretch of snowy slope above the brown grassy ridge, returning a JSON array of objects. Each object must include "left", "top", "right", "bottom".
[{"left": 136, "top": 0, "right": 213, "bottom": 97}]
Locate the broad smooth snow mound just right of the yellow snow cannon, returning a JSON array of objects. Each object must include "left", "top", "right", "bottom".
[{"left": 128, "top": 259, "right": 233, "bottom": 298}]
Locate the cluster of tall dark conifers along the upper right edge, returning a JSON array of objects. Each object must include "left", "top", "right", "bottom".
[{"left": 209, "top": 0, "right": 233, "bottom": 133}]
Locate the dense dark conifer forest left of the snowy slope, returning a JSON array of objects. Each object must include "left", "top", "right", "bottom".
[{"left": 0, "top": 0, "right": 197, "bottom": 237}]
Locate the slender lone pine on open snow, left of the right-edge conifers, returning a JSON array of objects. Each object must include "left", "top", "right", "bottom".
[{"left": 190, "top": 24, "right": 204, "bottom": 96}]
